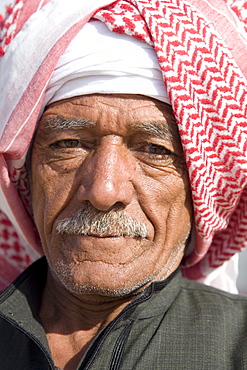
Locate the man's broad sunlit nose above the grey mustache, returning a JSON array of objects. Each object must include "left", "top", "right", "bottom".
[{"left": 79, "top": 137, "right": 134, "bottom": 211}]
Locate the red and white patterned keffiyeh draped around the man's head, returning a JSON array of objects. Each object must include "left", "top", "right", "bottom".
[{"left": 0, "top": 0, "right": 247, "bottom": 288}]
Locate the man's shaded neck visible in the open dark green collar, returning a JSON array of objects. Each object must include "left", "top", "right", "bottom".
[{"left": 39, "top": 272, "right": 133, "bottom": 370}]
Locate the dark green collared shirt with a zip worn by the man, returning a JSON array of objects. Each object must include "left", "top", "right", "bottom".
[{"left": 0, "top": 258, "right": 247, "bottom": 370}]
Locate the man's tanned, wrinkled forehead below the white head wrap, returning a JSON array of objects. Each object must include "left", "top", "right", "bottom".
[{"left": 41, "top": 94, "right": 179, "bottom": 140}]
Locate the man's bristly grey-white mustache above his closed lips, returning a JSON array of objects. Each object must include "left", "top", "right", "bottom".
[{"left": 56, "top": 204, "right": 148, "bottom": 238}]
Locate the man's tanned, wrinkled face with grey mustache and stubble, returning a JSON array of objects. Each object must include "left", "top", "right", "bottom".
[{"left": 31, "top": 94, "right": 191, "bottom": 296}]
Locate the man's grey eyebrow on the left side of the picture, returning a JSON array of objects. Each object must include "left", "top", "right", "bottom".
[{"left": 46, "top": 116, "right": 95, "bottom": 130}]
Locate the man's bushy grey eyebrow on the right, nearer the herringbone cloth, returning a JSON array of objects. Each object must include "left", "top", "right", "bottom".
[{"left": 133, "top": 121, "right": 179, "bottom": 141}]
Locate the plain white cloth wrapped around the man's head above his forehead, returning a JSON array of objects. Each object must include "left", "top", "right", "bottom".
[{"left": 43, "top": 20, "right": 170, "bottom": 108}]
